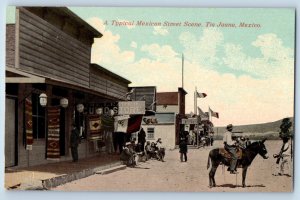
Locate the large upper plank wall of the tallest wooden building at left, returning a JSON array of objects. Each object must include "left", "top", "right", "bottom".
[{"left": 19, "top": 8, "right": 91, "bottom": 87}]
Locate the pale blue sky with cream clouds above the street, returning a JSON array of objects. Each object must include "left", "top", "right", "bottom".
[{"left": 5, "top": 7, "right": 295, "bottom": 126}]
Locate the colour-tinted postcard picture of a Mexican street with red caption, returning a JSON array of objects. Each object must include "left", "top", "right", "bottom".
[{"left": 4, "top": 6, "right": 295, "bottom": 192}]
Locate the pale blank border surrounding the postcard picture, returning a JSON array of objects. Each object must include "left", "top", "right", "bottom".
[{"left": 0, "top": 0, "right": 300, "bottom": 200}]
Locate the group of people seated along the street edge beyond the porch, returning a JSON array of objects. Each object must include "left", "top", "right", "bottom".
[{"left": 120, "top": 128, "right": 165, "bottom": 167}]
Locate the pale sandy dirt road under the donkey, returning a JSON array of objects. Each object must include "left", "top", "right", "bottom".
[{"left": 53, "top": 141, "right": 293, "bottom": 192}]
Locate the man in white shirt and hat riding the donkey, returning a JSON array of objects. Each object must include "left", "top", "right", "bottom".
[{"left": 223, "top": 124, "right": 237, "bottom": 174}]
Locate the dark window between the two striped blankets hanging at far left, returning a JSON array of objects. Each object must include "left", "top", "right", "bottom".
[{"left": 32, "top": 94, "right": 46, "bottom": 139}]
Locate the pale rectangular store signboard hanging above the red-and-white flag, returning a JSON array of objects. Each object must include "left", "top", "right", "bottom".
[{"left": 118, "top": 101, "right": 145, "bottom": 115}]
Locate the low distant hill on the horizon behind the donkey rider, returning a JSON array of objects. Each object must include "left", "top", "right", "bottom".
[{"left": 214, "top": 117, "right": 294, "bottom": 139}]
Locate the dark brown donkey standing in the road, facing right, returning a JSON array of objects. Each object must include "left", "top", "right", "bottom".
[{"left": 207, "top": 139, "right": 268, "bottom": 188}]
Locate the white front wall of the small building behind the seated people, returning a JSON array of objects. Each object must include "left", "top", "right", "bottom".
[{"left": 142, "top": 124, "right": 176, "bottom": 149}]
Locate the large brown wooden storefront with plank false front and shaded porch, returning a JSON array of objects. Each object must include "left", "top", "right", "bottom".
[{"left": 5, "top": 7, "right": 130, "bottom": 167}]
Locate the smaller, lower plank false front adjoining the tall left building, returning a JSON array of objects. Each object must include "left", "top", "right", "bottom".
[{"left": 90, "top": 67, "right": 128, "bottom": 98}]
